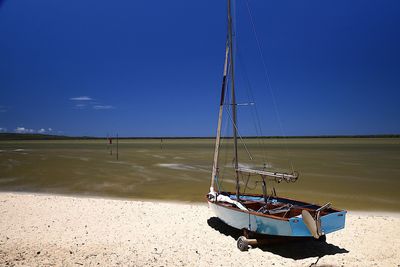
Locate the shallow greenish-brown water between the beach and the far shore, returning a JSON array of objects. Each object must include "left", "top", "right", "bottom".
[{"left": 0, "top": 138, "right": 400, "bottom": 211}]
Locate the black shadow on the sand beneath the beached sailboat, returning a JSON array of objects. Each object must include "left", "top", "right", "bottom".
[{"left": 207, "top": 217, "right": 349, "bottom": 260}]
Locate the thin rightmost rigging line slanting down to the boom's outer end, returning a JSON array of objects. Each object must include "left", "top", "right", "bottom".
[{"left": 245, "top": 0, "right": 294, "bottom": 172}]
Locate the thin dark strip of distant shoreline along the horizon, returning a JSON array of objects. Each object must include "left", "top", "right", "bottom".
[{"left": 0, "top": 133, "right": 400, "bottom": 141}]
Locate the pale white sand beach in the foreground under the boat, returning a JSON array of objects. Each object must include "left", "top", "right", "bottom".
[{"left": 0, "top": 193, "right": 400, "bottom": 266}]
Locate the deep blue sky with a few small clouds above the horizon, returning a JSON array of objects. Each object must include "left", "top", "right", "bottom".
[{"left": 0, "top": 0, "right": 400, "bottom": 136}]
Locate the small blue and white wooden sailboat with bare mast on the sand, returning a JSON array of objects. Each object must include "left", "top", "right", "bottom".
[{"left": 207, "top": 0, "right": 346, "bottom": 250}]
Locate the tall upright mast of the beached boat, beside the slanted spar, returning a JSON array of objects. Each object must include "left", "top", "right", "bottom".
[{"left": 228, "top": 0, "right": 240, "bottom": 201}]
